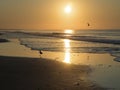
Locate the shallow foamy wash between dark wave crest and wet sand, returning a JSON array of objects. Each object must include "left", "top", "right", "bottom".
[{"left": 20, "top": 39, "right": 120, "bottom": 55}]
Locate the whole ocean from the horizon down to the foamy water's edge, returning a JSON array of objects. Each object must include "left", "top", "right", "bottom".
[{"left": 1, "top": 30, "right": 120, "bottom": 61}]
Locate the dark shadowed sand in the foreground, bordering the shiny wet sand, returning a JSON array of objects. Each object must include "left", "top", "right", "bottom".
[{"left": 0, "top": 56, "right": 104, "bottom": 90}]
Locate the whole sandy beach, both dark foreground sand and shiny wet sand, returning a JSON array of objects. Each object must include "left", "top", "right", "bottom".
[{"left": 0, "top": 36, "right": 119, "bottom": 90}]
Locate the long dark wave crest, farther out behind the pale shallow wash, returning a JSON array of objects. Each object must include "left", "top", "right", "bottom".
[{"left": 21, "top": 33, "right": 120, "bottom": 45}]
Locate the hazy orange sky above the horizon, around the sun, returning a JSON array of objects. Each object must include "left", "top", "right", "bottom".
[{"left": 0, "top": 0, "right": 120, "bottom": 29}]
